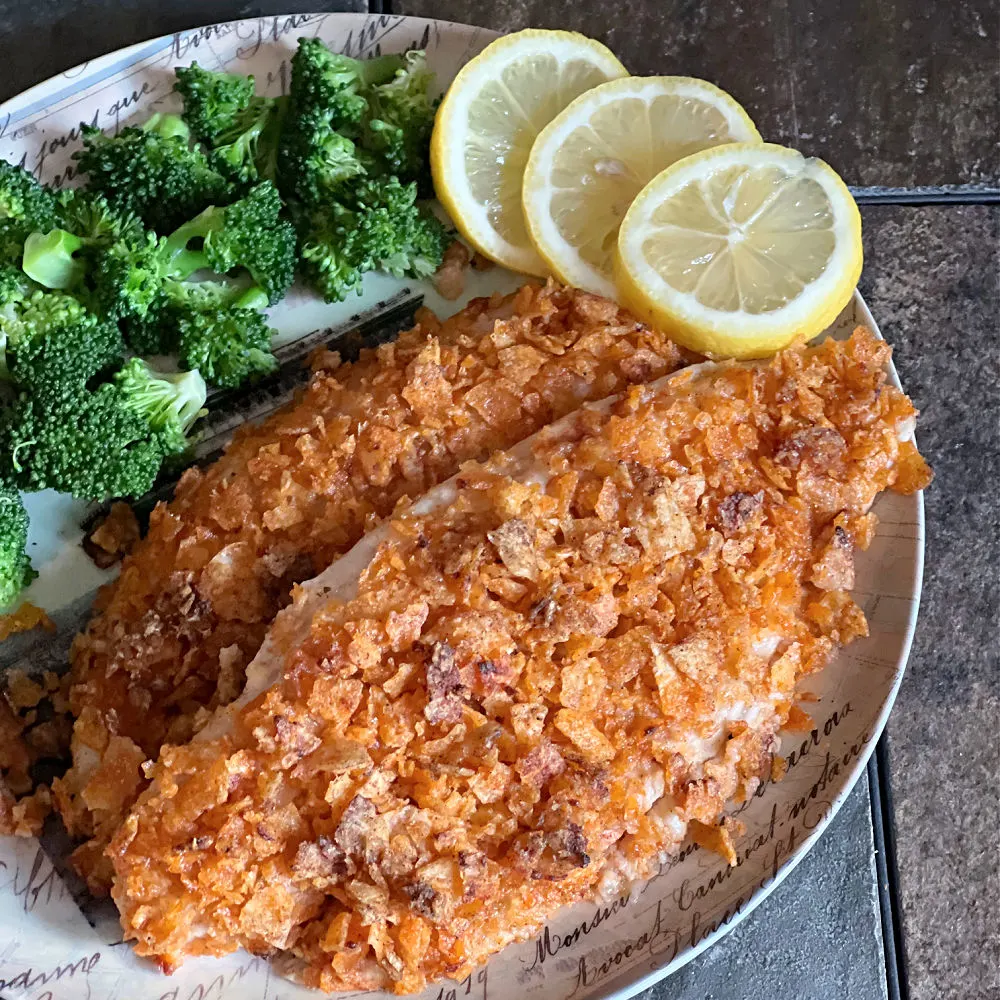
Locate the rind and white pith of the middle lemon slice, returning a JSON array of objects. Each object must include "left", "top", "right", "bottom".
[{"left": 522, "top": 76, "right": 762, "bottom": 298}]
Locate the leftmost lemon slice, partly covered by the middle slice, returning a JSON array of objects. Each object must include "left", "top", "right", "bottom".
[{"left": 431, "top": 29, "right": 627, "bottom": 275}]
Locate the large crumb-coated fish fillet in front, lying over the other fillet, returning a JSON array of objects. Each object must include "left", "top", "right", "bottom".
[{"left": 112, "top": 331, "right": 929, "bottom": 993}]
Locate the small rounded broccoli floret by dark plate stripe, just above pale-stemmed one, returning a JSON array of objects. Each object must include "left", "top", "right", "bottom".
[{"left": 177, "top": 309, "right": 278, "bottom": 389}]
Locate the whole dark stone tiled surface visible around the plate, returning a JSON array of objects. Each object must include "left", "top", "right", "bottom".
[{"left": 0, "top": 0, "right": 1000, "bottom": 1000}]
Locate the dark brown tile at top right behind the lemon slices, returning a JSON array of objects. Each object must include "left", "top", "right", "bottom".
[{"left": 392, "top": 0, "right": 1000, "bottom": 187}]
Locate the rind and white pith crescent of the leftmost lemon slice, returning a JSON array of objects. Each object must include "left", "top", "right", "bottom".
[{"left": 430, "top": 29, "right": 628, "bottom": 277}]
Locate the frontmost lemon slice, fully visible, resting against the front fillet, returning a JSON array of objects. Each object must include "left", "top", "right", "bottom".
[{"left": 615, "top": 144, "right": 862, "bottom": 358}]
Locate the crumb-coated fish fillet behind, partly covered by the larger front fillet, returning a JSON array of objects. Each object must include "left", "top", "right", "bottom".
[{"left": 54, "top": 285, "right": 682, "bottom": 892}]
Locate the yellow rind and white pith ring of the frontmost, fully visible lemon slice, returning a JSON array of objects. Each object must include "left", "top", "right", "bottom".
[{"left": 615, "top": 143, "right": 863, "bottom": 358}]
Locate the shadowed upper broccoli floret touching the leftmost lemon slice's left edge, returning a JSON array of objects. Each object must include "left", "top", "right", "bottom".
[{"left": 364, "top": 52, "right": 438, "bottom": 195}]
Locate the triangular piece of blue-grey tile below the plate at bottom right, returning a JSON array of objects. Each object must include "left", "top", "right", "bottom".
[{"left": 642, "top": 776, "right": 888, "bottom": 1000}]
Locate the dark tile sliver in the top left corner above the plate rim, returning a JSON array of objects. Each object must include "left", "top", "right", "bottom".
[{"left": 0, "top": 0, "right": 368, "bottom": 104}]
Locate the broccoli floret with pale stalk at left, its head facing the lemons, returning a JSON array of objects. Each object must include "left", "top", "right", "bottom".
[{"left": 166, "top": 181, "right": 295, "bottom": 303}]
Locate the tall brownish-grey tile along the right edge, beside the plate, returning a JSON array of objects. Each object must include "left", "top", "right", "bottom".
[{"left": 861, "top": 206, "right": 1000, "bottom": 1000}]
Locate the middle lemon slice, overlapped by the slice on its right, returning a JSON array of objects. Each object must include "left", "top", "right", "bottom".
[{"left": 521, "top": 76, "right": 761, "bottom": 297}]
